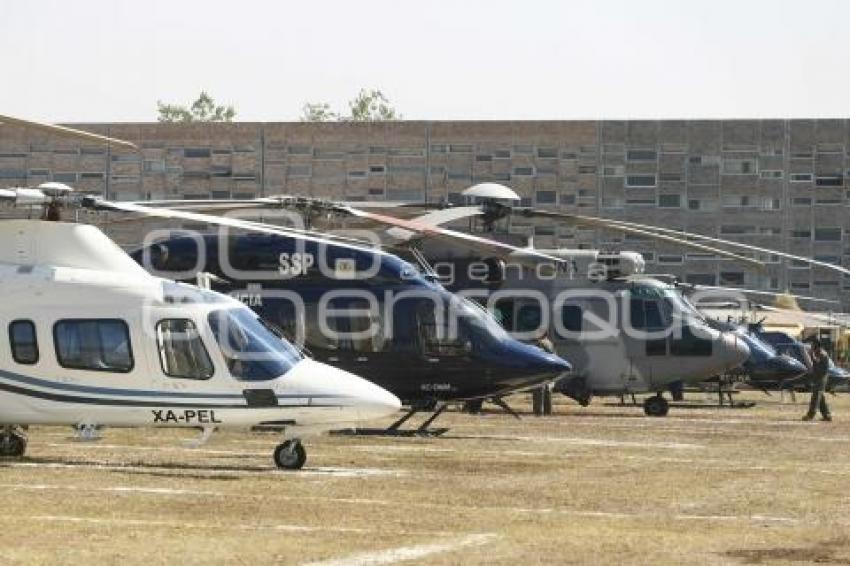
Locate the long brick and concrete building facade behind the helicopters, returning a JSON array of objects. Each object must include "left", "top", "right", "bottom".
[{"left": 0, "top": 119, "right": 850, "bottom": 308}]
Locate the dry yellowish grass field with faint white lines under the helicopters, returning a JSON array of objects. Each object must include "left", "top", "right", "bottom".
[{"left": 0, "top": 393, "right": 850, "bottom": 565}]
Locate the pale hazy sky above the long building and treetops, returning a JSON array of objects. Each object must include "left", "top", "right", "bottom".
[{"left": 0, "top": 0, "right": 850, "bottom": 122}]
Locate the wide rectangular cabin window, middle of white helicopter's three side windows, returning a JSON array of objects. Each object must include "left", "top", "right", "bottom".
[{"left": 53, "top": 319, "right": 133, "bottom": 373}]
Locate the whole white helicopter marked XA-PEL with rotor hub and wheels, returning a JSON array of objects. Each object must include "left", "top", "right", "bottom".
[{"left": 0, "top": 117, "right": 400, "bottom": 469}]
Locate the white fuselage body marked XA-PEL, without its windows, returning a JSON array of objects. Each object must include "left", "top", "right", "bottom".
[{"left": 0, "top": 221, "right": 399, "bottom": 432}]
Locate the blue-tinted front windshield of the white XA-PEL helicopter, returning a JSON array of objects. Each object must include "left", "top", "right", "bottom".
[{"left": 208, "top": 308, "right": 302, "bottom": 381}]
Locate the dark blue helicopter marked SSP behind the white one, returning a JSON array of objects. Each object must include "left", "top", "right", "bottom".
[{"left": 87, "top": 199, "right": 571, "bottom": 434}]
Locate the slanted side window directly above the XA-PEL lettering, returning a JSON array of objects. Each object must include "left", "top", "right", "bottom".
[{"left": 156, "top": 319, "right": 215, "bottom": 379}]
